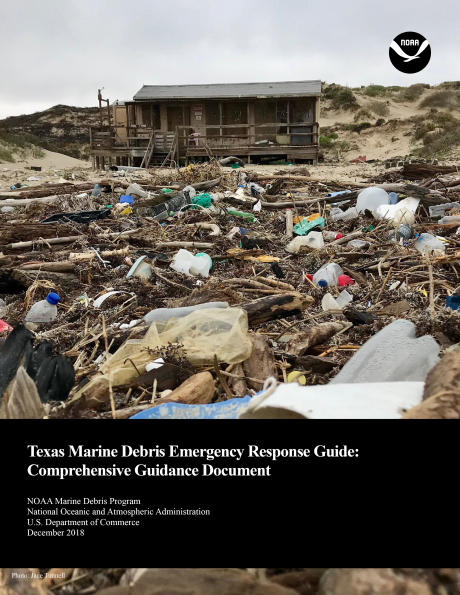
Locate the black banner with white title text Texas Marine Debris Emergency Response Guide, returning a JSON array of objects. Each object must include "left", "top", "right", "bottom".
[{"left": 2, "top": 420, "right": 458, "bottom": 567}]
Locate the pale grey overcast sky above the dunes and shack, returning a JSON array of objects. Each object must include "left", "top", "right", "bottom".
[{"left": 0, "top": 0, "right": 460, "bottom": 118}]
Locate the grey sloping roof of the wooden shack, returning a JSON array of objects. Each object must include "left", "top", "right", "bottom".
[{"left": 133, "top": 80, "right": 321, "bottom": 101}]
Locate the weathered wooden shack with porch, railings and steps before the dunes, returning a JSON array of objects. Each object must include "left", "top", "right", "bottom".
[{"left": 91, "top": 80, "right": 321, "bottom": 168}]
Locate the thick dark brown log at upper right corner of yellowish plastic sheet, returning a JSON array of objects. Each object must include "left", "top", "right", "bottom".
[{"left": 239, "top": 293, "right": 314, "bottom": 326}]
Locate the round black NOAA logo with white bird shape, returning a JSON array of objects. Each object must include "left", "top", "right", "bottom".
[{"left": 390, "top": 31, "right": 431, "bottom": 74}]
